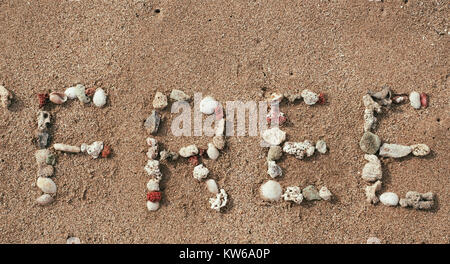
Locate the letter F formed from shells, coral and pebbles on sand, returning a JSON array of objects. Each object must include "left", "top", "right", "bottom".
[{"left": 33, "top": 84, "right": 110, "bottom": 206}]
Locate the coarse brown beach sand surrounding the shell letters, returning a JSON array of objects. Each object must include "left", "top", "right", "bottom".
[{"left": 0, "top": 0, "right": 450, "bottom": 243}]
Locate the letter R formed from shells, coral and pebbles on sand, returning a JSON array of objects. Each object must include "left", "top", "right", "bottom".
[{"left": 144, "top": 89, "right": 228, "bottom": 212}]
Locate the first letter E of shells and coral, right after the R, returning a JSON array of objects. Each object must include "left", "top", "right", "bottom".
[{"left": 259, "top": 93, "right": 332, "bottom": 204}]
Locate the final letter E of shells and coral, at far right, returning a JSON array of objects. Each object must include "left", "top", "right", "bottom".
[{"left": 359, "top": 86, "right": 434, "bottom": 209}]
